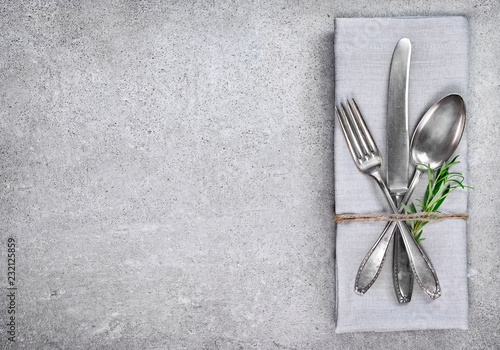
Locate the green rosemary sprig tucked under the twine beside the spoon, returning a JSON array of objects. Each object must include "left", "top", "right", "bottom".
[{"left": 402, "top": 156, "right": 473, "bottom": 242}]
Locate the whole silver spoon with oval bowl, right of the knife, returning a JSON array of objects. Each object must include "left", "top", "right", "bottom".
[{"left": 354, "top": 94, "right": 465, "bottom": 294}]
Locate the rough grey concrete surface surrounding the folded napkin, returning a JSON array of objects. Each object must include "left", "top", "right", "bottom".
[{"left": 0, "top": 0, "right": 500, "bottom": 349}]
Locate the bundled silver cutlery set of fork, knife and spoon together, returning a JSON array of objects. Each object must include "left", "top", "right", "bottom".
[{"left": 336, "top": 39, "right": 465, "bottom": 303}]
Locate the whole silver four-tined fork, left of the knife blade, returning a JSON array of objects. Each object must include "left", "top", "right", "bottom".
[{"left": 335, "top": 99, "right": 441, "bottom": 299}]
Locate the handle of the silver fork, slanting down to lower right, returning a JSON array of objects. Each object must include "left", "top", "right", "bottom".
[{"left": 374, "top": 174, "right": 441, "bottom": 299}]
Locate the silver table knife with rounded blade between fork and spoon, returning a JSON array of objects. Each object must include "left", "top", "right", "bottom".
[{"left": 387, "top": 38, "right": 413, "bottom": 303}]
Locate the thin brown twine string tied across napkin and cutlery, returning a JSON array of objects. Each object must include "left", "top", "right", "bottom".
[{"left": 333, "top": 212, "right": 469, "bottom": 223}]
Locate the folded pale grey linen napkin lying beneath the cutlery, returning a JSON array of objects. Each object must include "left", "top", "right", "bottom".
[{"left": 334, "top": 17, "right": 469, "bottom": 333}]
